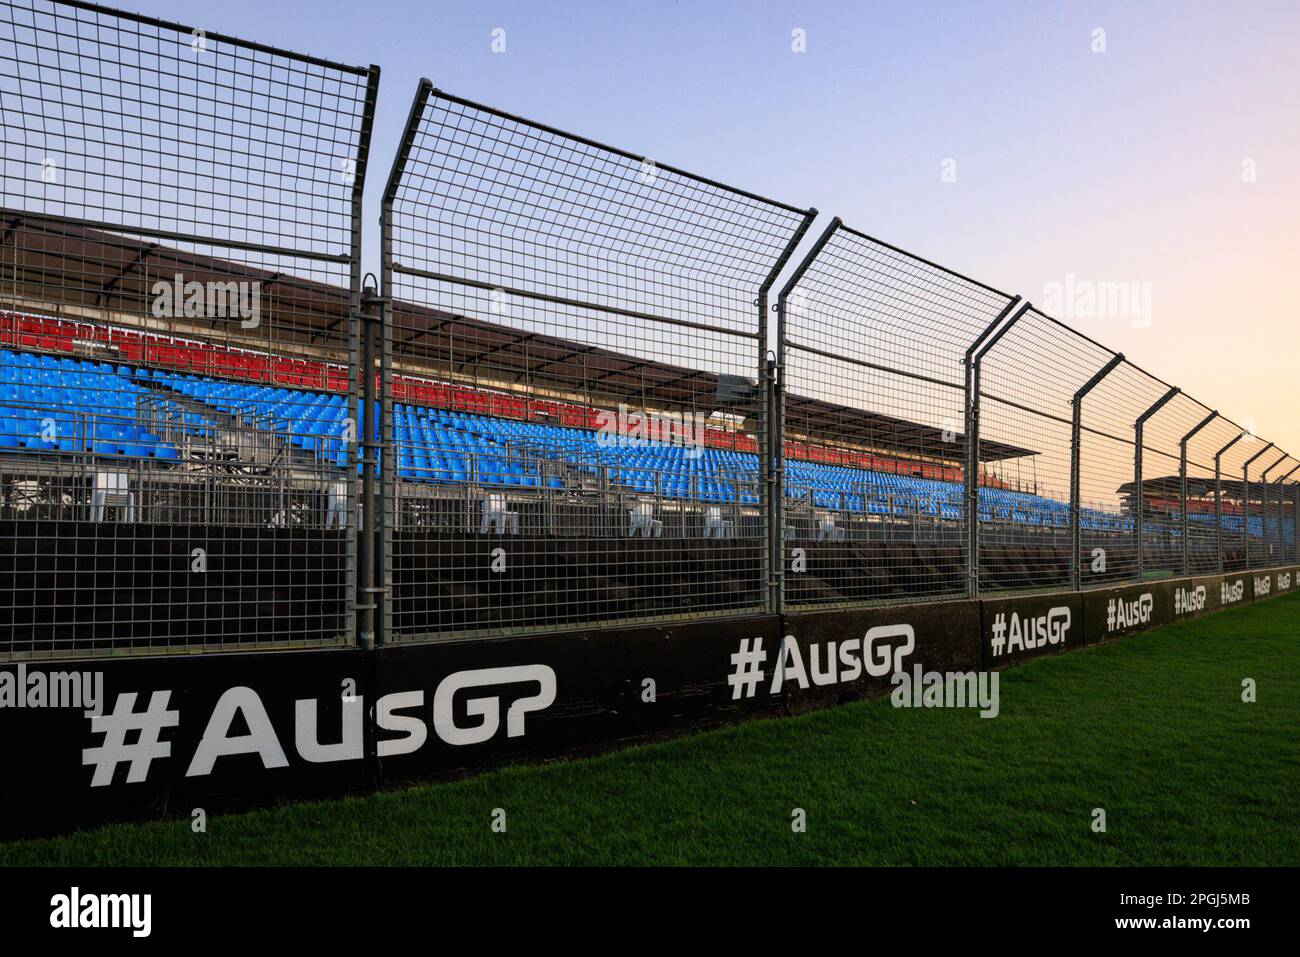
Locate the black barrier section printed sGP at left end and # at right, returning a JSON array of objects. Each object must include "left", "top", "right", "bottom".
[{"left": 376, "top": 615, "right": 784, "bottom": 781}]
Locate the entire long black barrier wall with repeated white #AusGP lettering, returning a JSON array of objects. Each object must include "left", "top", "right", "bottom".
[{"left": 0, "top": 567, "right": 1300, "bottom": 839}]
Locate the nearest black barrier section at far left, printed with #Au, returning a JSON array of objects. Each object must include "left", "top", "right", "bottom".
[{"left": 0, "top": 649, "right": 376, "bottom": 837}]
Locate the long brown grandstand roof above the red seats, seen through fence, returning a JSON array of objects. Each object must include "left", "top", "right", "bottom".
[{"left": 0, "top": 209, "right": 1035, "bottom": 463}]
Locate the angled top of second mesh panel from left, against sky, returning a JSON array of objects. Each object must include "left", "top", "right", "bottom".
[{"left": 385, "top": 81, "right": 809, "bottom": 351}]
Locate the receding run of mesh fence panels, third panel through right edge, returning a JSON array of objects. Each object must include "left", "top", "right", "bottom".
[{"left": 776, "top": 220, "right": 1300, "bottom": 609}]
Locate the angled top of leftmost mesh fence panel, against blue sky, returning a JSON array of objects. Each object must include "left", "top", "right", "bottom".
[{"left": 0, "top": 0, "right": 378, "bottom": 265}]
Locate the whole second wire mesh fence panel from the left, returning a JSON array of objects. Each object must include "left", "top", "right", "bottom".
[{"left": 384, "top": 85, "right": 810, "bottom": 640}]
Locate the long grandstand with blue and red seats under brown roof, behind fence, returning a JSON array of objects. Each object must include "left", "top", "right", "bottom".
[{"left": 0, "top": 221, "right": 1295, "bottom": 646}]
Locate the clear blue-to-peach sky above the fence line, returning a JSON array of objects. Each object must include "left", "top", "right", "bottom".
[{"left": 126, "top": 0, "right": 1300, "bottom": 454}]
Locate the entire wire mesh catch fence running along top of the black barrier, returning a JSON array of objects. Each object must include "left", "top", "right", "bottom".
[{"left": 0, "top": 0, "right": 1300, "bottom": 658}]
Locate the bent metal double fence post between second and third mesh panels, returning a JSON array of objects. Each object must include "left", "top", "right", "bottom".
[{"left": 757, "top": 209, "right": 816, "bottom": 615}]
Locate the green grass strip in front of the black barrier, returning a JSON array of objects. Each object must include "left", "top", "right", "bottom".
[{"left": 0, "top": 594, "right": 1300, "bottom": 865}]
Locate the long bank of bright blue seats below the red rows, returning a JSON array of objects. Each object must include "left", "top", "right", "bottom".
[{"left": 0, "top": 350, "right": 1294, "bottom": 537}]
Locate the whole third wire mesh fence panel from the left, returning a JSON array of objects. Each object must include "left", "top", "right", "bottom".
[{"left": 780, "top": 224, "right": 1023, "bottom": 607}]
